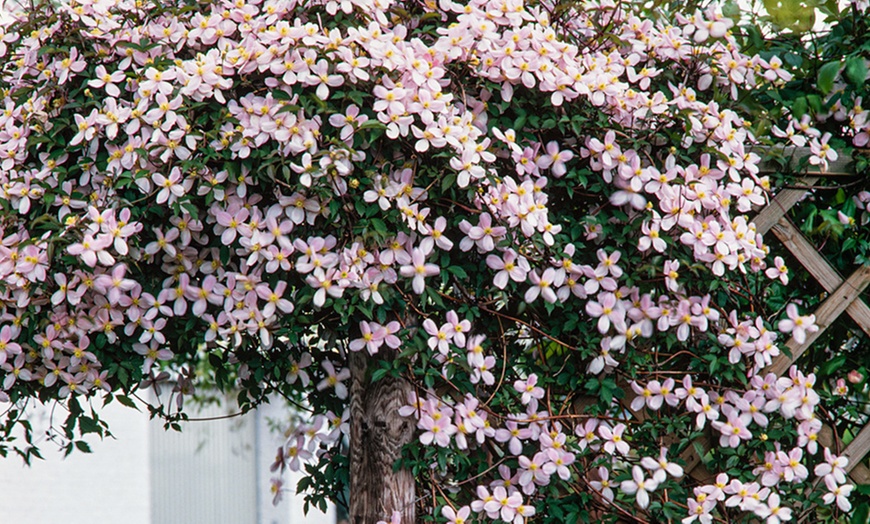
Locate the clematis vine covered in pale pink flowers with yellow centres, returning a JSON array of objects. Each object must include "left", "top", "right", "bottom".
[{"left": 0, "top": 0, "right": 870, "bottom": 524}]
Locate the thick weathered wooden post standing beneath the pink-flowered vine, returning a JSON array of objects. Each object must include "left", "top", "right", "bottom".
[{"left": 349, "top": 351, "right": 415, "bottom": 524}]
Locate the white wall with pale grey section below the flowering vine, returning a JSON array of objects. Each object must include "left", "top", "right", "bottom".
[{"left": 0, "top": 403, "right": 335, "bottom": 524}]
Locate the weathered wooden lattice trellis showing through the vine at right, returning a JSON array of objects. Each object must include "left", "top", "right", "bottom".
[{"left": 623, "top": 148, "right": 870, "bottom": 484}]
